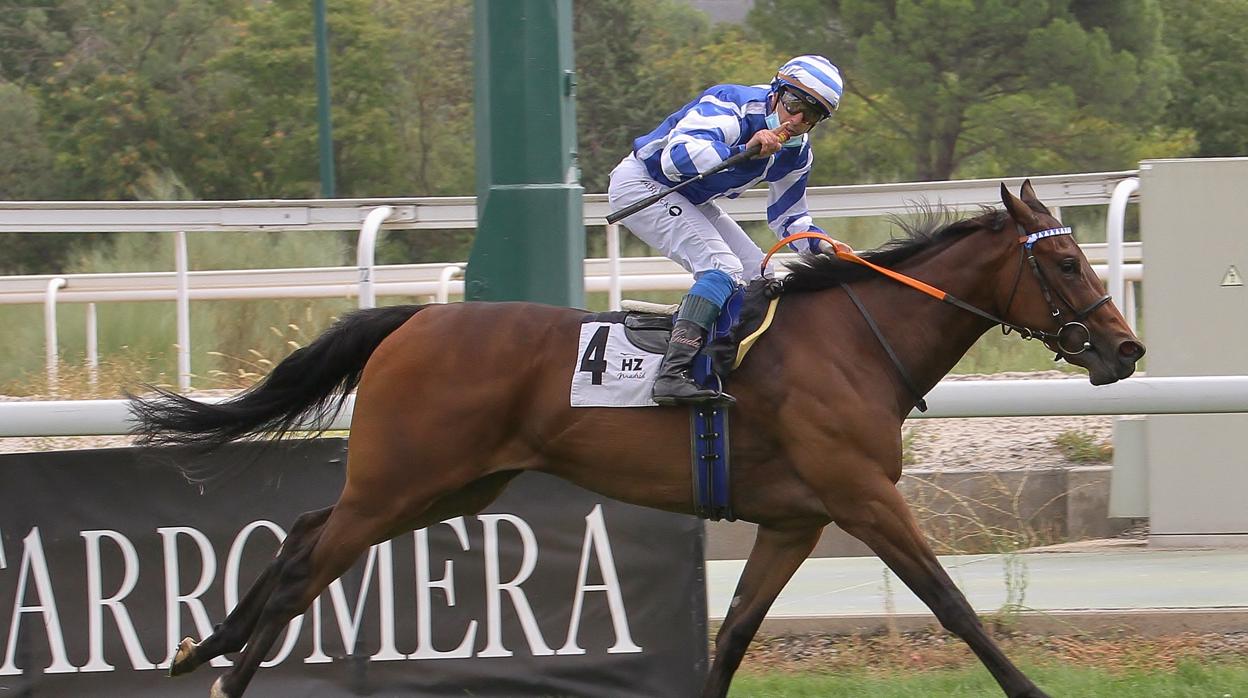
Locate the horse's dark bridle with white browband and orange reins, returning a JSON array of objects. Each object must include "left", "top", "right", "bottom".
[{"left": 761, "top": 224, "right": 1109, "bottom": 358}]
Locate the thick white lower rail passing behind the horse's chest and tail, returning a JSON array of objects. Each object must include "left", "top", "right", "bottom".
[{"left": 0, "top": 376, "right": 1248, "bottom": 438}]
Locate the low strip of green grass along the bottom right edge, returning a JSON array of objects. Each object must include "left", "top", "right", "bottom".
[{"left": 729, "top": 659, "right": 1248, "bottom": 698}]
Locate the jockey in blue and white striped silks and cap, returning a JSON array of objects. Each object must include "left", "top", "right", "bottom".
[{"left": 608, "top": 55, "right": 847, "bottom": 405}]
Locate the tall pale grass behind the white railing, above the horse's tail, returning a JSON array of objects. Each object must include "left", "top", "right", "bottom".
[{"left": 0, "top": 232, "right": 364, "bottom": 395}]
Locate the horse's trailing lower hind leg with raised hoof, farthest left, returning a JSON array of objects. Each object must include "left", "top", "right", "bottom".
[{"left": 168, "top": 507, "right": 333, "bottom": 677}]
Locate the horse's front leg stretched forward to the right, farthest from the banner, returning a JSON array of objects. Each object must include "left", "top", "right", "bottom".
[{"left": 830, "top": 476, "right": 1048, "bottom": 698}]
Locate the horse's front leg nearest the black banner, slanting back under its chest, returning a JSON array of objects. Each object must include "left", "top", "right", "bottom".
[{"left": 703, "top": 526, "right": 824, "bottom": 698}]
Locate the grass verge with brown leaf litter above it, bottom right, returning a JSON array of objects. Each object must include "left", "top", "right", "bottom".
[{"left": 730, "top": 627, "right": 1248, "bottom": 698}]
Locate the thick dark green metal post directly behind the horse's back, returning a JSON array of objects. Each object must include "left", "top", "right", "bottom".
[{"left": 466, "top": 0, "right": 585, "bottom": 306}]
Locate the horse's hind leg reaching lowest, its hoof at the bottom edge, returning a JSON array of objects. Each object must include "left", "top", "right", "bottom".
[{"left": 212, "top": 472, "right": 517, "bottom": 698}]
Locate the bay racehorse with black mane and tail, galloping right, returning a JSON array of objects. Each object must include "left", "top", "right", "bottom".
[{"left": 131, "top": 182, "right": 1144, "bottom": 698}]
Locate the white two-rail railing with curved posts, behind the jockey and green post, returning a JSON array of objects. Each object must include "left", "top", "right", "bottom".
[{"left": 0, "top": 171, "right": 1141, "bottom": 391}]
